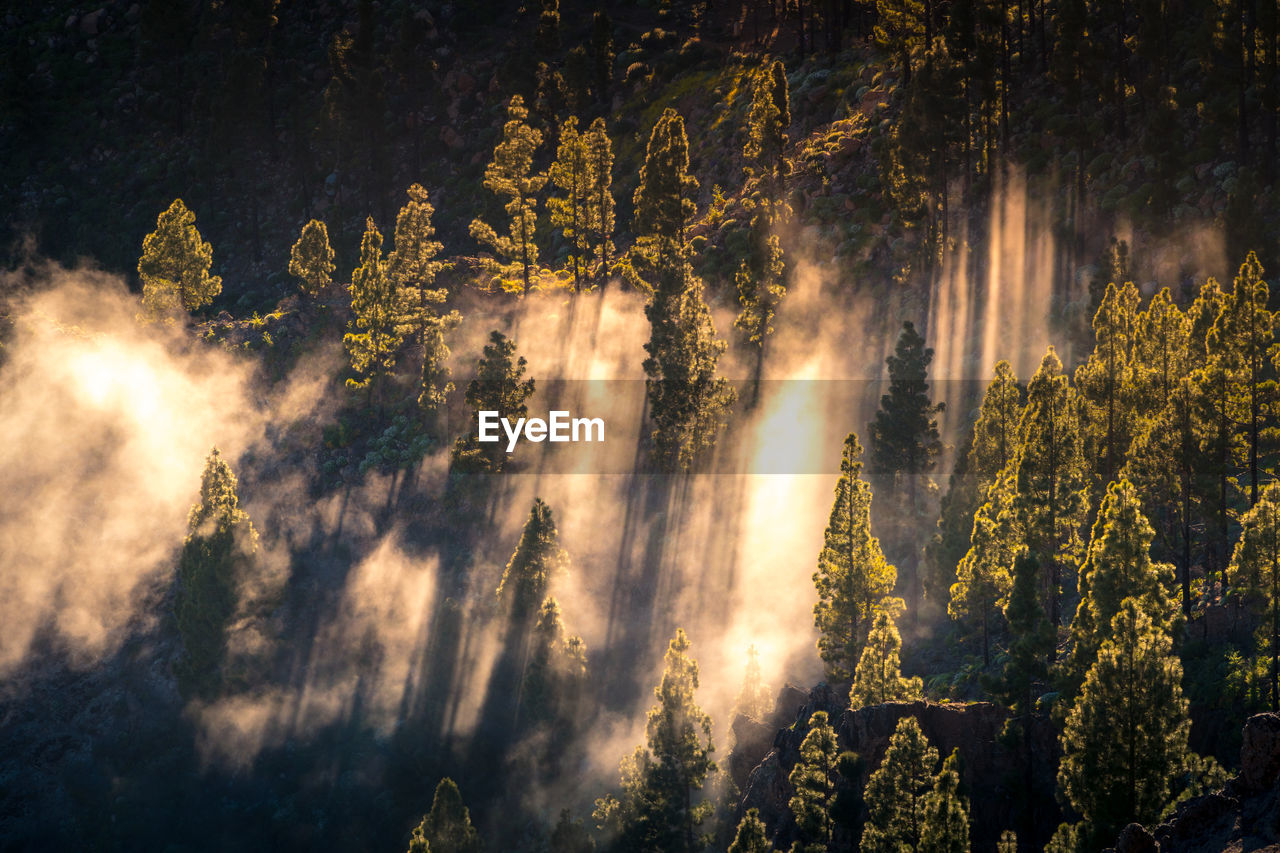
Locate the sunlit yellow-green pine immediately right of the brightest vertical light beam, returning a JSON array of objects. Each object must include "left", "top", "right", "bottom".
[{"left": 813, "top": 433, "right": 897, "bottom": 680}]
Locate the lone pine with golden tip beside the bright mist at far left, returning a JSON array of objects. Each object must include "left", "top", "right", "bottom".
[{"left": 173, "top": 447, "right": 257, "bottom": 697}]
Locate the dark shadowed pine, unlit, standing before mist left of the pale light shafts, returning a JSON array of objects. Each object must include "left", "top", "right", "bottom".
[{"left": 870, "top": 321, "right": 943, "bottom": 615}]
